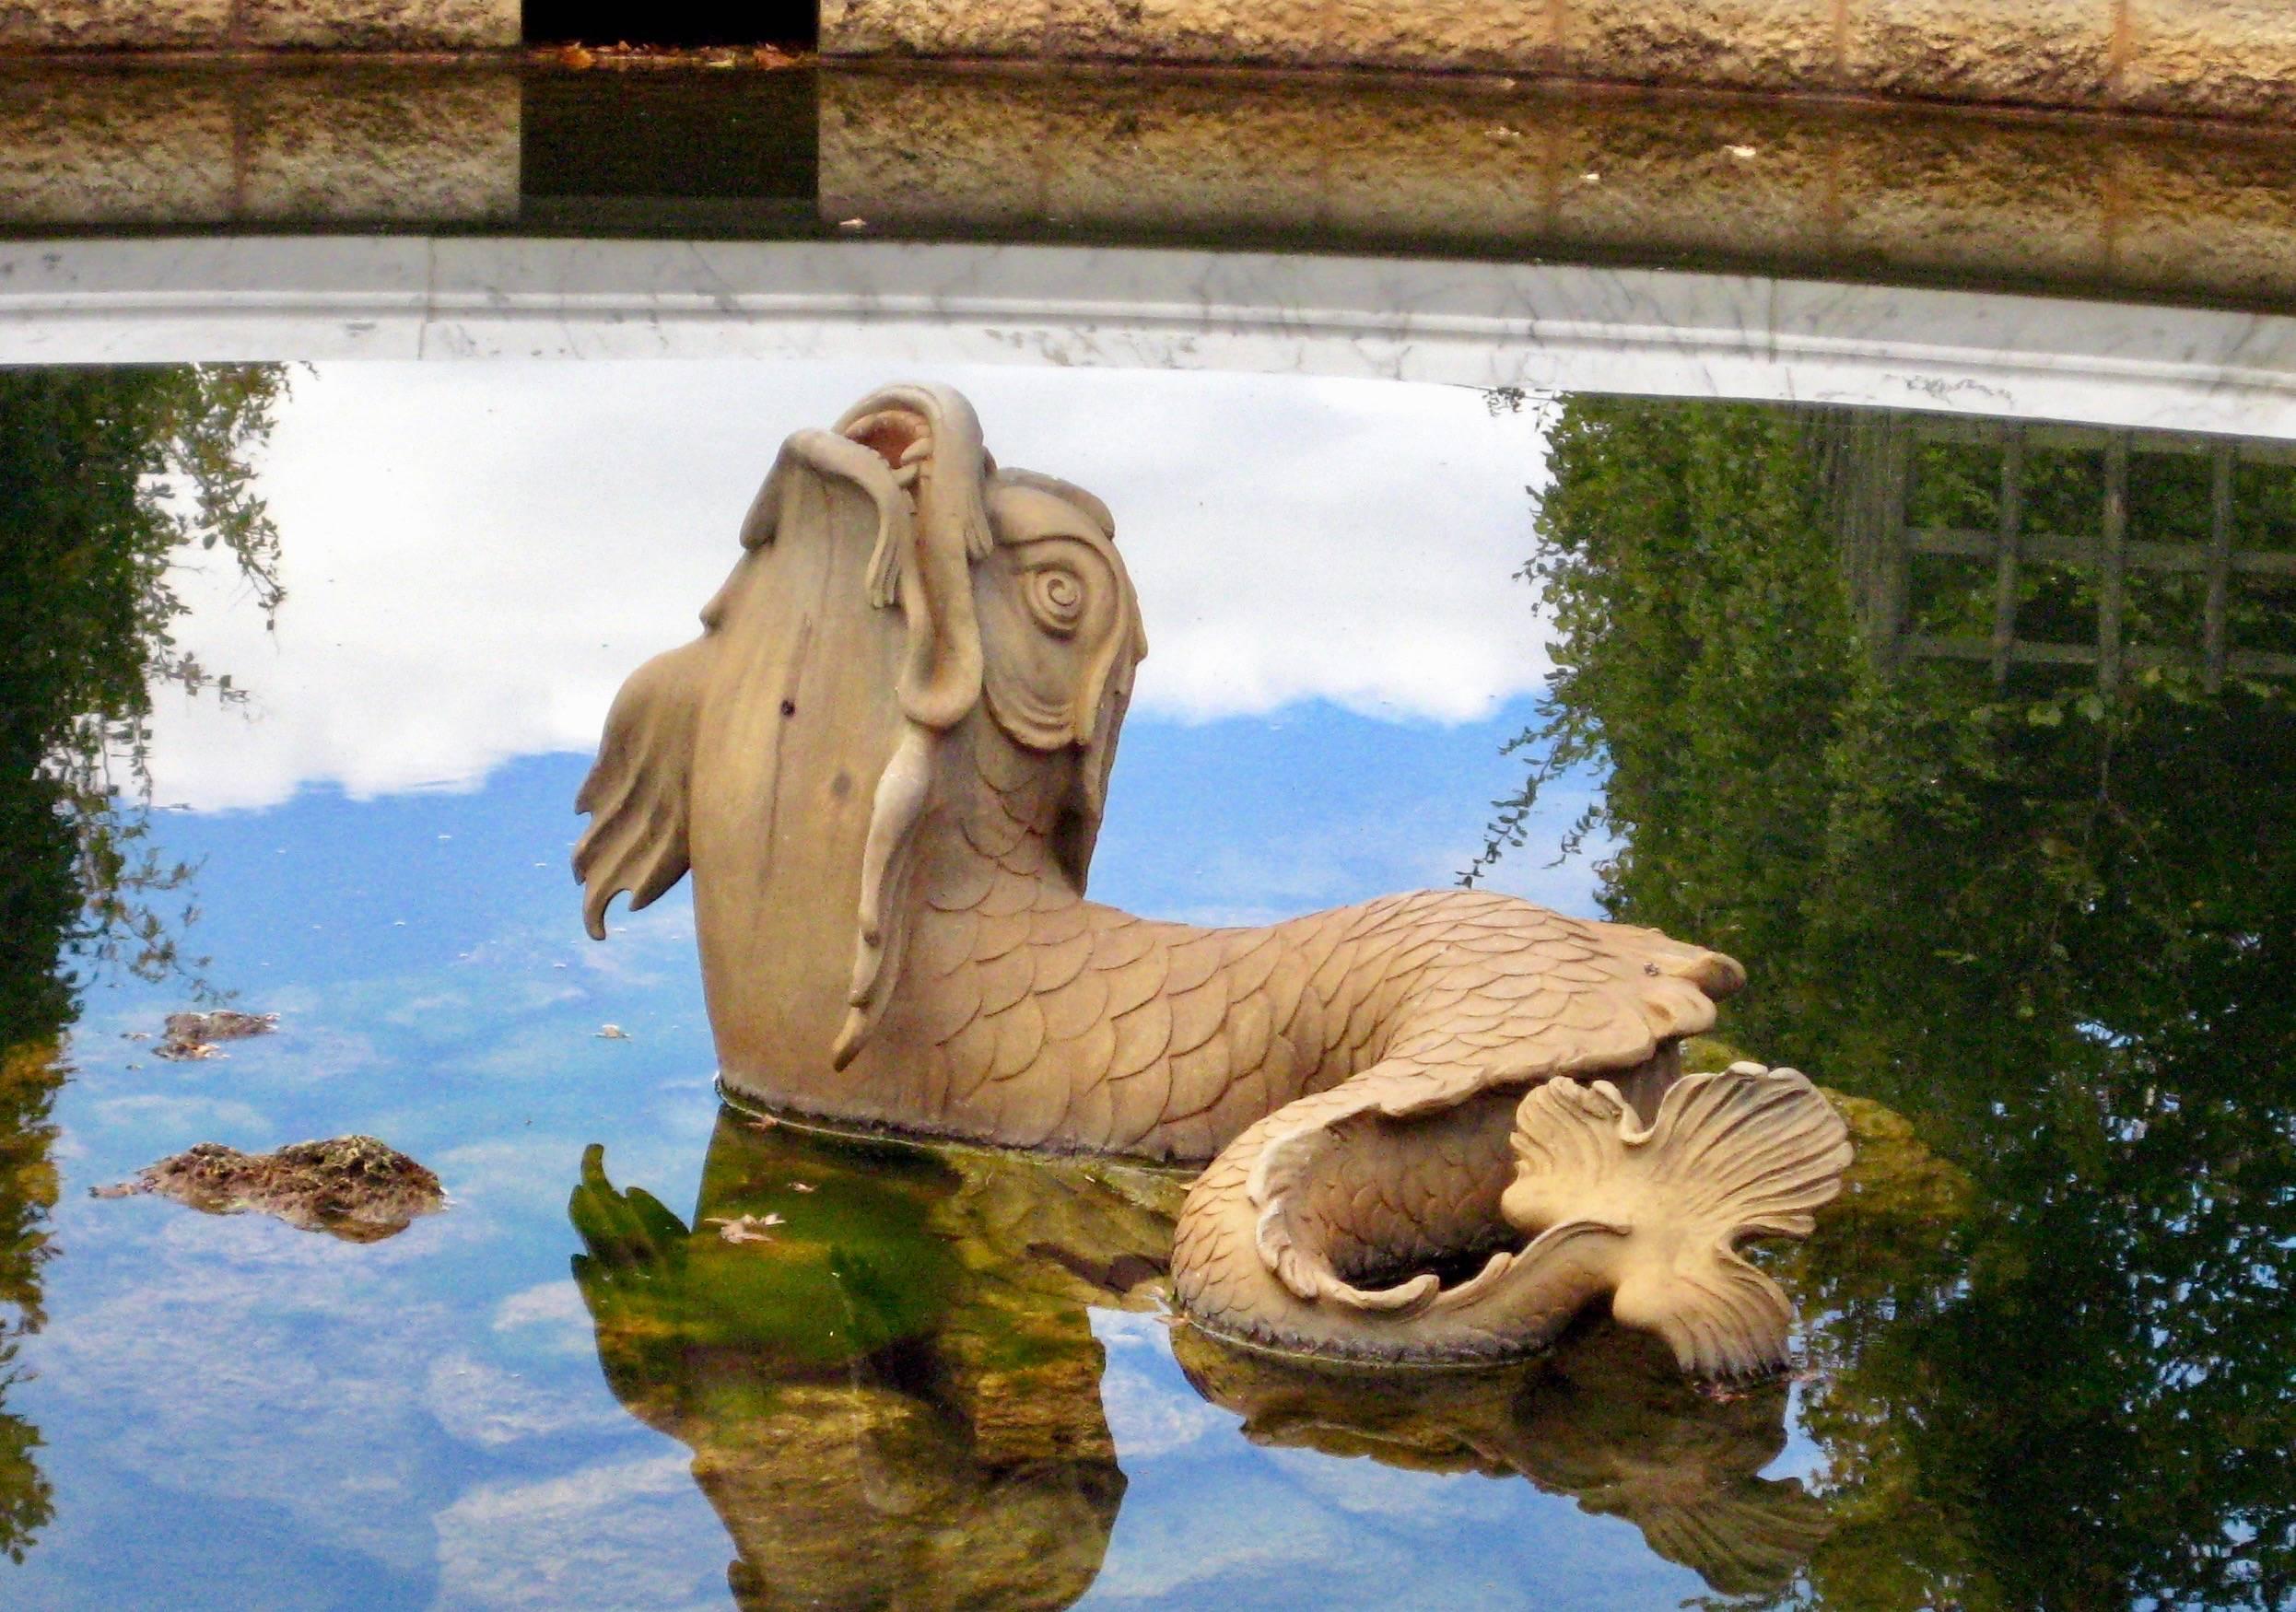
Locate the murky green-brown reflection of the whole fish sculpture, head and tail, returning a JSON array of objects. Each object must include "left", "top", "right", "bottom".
[{"left": 568, "top": 1109, "right": 1828, "bottom": 1610}]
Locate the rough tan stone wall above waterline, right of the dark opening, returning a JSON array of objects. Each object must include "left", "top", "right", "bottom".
[{"left": 820, "top": 0, "right": 2296, "bottom": 120}]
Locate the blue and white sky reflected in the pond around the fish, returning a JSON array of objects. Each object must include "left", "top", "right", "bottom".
[{"left": 0, "top": 365, "right": 1690, "bottom": 1607}]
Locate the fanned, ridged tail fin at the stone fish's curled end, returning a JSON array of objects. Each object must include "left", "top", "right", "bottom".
[{"left": 1502, "top": 1063, "right": 1851, "bottom": 1378}]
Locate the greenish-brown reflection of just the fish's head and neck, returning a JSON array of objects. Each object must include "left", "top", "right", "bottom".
[{"left": 568, "top": 1114, "right": 1171, "bottom": 1612}]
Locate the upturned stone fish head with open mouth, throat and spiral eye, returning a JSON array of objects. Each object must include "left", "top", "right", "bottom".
[{"left": 574, "top": 386, "right": 1148, "bottom": 1100}]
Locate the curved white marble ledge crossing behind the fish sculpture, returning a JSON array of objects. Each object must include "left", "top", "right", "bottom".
[{"left": 0, "top": 237, "right": 2296, "bottom": 438}]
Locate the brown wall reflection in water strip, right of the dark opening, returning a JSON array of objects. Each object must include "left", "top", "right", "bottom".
[{"left": 822, "top": 71, "right": 2296, "bottom": 303}]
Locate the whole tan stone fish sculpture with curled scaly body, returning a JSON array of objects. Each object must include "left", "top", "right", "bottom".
[{"left": 574, "top": 386, "right": 1851, "bottom": 1378}]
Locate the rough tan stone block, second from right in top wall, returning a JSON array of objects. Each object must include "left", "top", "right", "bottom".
[{"left": 1842, "top": 0, "right": 2113, "bottom": 106}]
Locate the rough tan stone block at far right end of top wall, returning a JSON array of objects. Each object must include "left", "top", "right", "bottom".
[{"left": 2119, "top": 0, "right": 2296, "bottom": 120}]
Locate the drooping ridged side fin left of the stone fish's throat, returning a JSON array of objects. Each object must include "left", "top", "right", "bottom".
[{"left": 574, "top": 638, "right": 714, "bottom": 940}]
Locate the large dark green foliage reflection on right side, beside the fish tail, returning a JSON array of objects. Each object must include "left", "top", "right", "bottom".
[{"left": 1470, "top": 397, "right": 2296, "bottom": 1607}]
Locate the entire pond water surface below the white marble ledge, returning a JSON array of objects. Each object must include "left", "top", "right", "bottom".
[{"left": 0, "top": 167, "right": 2296, "bottom": 1607}]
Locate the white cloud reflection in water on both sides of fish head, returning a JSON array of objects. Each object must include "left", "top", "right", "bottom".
[{"left": 154, "top": 363, "right": 1548, "bottom": 808}]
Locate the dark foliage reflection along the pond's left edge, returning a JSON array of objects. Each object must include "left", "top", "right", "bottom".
[{"left": 0, "top": 365, "right": 285, "bottom": 1559}]
